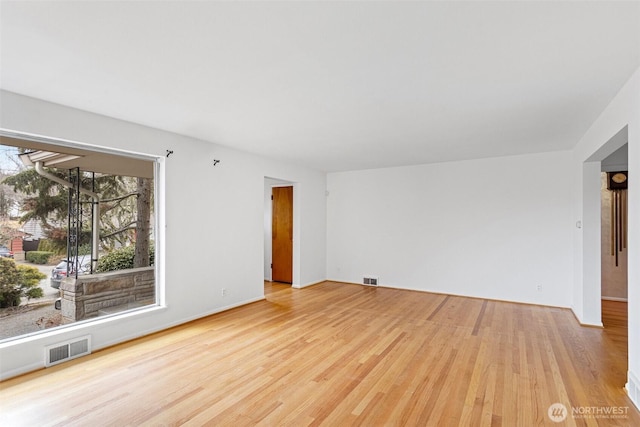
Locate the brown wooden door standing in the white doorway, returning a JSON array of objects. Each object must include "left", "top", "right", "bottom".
[{"left": 271, "top": 187, "right": 293, "bottom": 283}]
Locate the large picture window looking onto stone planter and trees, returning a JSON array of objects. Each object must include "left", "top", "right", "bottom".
[{"left": 0, "top": 131, "right": 158, "bottom": 341}]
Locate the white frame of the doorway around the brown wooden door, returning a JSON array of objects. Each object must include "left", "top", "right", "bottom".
[{"left": 263, "top": 176, "right": 301, "bottom": 289}]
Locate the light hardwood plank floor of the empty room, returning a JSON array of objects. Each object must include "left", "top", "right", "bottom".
[{"left": 0, "top": 282, "right": 640, "bottom": 426}]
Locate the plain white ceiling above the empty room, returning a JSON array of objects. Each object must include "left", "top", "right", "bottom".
[{"left": 0, "top": 1, "right": 640, "bottom": 171}]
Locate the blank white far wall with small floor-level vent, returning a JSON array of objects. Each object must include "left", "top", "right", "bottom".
[{"left": 327, "top": 152, "right": 574, "bottom": 307}]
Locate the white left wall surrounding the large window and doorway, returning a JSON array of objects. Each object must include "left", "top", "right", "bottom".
[{"left": 0, "top": 92, "right": 326, "bottom": 379}]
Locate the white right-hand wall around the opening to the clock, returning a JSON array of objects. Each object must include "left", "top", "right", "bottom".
[{"left": 573, "top": 68, "right": 640, "bottom": 407}]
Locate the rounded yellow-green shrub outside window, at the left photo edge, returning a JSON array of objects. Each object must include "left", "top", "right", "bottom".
[{"left": 0, "top": 258, "right": 47, "bottom": 308}]
